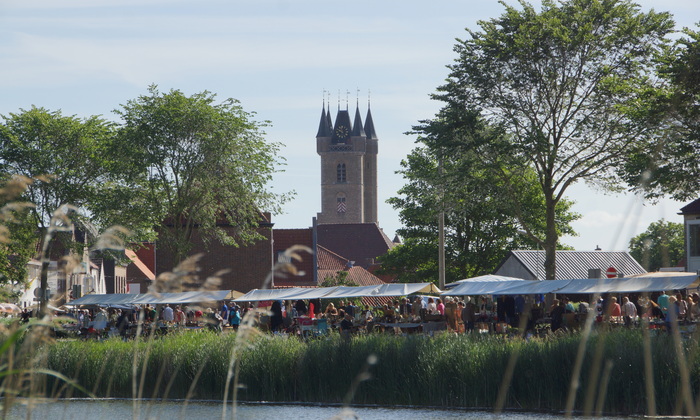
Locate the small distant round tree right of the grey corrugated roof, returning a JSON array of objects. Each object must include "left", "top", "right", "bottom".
[{"left": 629, "top": 219, "right": 685, "bottom": 271}]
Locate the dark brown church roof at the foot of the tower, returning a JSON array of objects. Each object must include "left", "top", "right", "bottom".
[{"left": 317, "top": 223, "right": 394, "bottom": 267}]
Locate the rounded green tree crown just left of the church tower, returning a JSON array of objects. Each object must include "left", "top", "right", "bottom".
[{"left": 113, "top": 86, "right": 289, "bottom": 261}]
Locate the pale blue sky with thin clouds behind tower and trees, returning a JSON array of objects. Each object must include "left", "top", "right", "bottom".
[{"left": 0, "top": 0, "right": 700, "bottom": 250}]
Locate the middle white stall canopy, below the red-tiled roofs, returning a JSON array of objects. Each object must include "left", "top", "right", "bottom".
[{"left": 234, "top": 283, "right": 440, "bottom": 302}]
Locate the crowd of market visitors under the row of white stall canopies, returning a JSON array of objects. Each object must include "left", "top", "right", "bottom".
[{"left": 32, "top": 292, "right": 700, "bottom": 338}]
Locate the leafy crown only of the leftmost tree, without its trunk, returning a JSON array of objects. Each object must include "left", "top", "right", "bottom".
[{"left": 0, "top": 107, "right": 114, "bottom": 229}]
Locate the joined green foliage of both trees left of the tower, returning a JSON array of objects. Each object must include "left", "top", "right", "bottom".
[{"left": 0, "top": 86, "right": 290, "bottom": 294}]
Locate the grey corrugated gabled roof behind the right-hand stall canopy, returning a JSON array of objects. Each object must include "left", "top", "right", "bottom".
[{"left": 495, "top": 250, "right": 646, "bottom": 280}]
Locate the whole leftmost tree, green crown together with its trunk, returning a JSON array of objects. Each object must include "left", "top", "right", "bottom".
[{"left": 0, "top": 107, "right": 114, "bottom": 306}]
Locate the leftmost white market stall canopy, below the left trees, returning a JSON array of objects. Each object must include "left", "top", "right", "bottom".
[{"left": 65, "top": 290, "right": 231, "bottom": 306}]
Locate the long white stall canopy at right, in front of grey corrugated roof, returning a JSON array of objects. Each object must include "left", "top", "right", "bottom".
[{"left": 441, "top": 272, "right": 700, "bottom": 296}]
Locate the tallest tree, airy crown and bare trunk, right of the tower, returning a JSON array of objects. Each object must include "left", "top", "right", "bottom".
[{"left": 435, "top": 0, "right": 673, "bottom": 279}]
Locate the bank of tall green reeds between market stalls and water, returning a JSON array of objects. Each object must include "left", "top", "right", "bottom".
[{"left": 31, "top": 330, "right": 700, "bottom": 414}]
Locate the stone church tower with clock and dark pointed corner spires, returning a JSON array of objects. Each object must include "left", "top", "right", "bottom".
[{"left": 316, "top": 99, "right": 378, "bottom": 224}]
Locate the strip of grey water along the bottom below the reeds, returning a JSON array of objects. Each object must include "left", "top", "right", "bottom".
[{"left": 9, "top": 399, "right": 620, "bottom": 420}]
